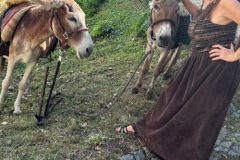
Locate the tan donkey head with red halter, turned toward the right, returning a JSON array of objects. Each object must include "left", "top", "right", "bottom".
[{"left": 52, "top": 0, "right": 93, "bottom": 58}]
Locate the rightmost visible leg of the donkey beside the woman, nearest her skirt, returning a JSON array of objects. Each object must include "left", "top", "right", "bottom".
[{"left": 163, "top": 46, "right": 181, "bottom": 80}]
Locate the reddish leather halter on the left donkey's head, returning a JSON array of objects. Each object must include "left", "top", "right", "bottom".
[{"left": 50, "top": 9, "right": 88, "bottom": 50}]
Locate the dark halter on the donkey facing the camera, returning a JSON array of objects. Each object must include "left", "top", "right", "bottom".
[{"left": 149, "top": 8, "right": 180, "bottom": 47}]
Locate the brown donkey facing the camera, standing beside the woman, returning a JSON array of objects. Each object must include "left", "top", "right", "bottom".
[{"left": 132, "top": 0, "right": 189, "bottom": 99}]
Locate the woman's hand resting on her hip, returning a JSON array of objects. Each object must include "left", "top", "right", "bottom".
[{"left": 209, "top": 44, "right": 240, "bottom": 62}]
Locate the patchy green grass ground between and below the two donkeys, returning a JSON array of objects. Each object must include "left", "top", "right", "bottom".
[{"left": 0, "top": 0, "right": 239, "bottom": 160}]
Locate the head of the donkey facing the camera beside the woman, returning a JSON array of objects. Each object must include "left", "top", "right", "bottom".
[{"left": 150, "top": 0, "right": 179, "bottom": 47}]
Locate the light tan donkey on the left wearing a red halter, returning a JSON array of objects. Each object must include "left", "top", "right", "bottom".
[{"left": 0, "top": 0, "right": 93, "bottom": 114}]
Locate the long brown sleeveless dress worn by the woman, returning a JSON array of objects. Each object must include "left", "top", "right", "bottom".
[{"left": 133, "top": 2, "right": 240, "bottom": 160}]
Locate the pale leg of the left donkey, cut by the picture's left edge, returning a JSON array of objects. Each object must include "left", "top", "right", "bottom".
[{"left": 0, "top": 58, "right": 16, "bottom": 112}]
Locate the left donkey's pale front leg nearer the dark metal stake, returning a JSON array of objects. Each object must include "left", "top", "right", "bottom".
[{"left": 13, "top": 62, "right": 36, "bottom": 114}]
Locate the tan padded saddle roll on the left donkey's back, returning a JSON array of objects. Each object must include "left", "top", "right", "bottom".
[{"left": 1, "top": 3, "right": 32, "bottom": 42}]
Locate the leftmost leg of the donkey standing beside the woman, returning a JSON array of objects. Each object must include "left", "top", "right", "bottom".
[{"left": 132, "top": 45, "right": 154, "bottom": 94}]
